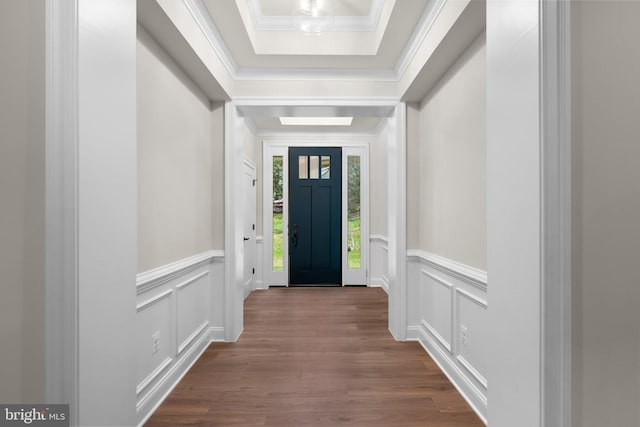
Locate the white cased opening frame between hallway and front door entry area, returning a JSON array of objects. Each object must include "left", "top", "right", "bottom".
[{"left": 225, "top": 98, "right": 407, "bottom": 341}]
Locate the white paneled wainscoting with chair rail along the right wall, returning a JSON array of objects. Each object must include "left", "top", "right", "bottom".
[{"left": 407, "top": 250, "right": 488, "bottom": 423}]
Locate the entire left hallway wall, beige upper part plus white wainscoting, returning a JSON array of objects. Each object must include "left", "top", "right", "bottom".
[{"left": 134, "top": 25, "right": 228, "bottom": 424}]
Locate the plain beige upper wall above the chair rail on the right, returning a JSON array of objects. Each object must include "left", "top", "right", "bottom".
[{"left": 418, "top": 33, "right": 487, "bottom": 270}]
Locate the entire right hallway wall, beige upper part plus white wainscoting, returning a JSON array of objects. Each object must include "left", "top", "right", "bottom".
[{"left": 407, "top": 34, "right": 489, "bottom": 420}]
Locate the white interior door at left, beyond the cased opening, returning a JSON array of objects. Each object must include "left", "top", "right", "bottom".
[{"left": 242, "top": 161, "right": 256, "bottom": 298}]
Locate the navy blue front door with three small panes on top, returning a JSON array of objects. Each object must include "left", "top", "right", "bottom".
[{"left": 289, "top": 147, "right": 342, "bottom": 286}]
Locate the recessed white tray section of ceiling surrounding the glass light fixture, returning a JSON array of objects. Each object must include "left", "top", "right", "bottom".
[{"left": 200, "top": 0, "right": 429, "bottom": 74}]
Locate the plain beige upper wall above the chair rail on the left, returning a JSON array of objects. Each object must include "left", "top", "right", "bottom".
[{"left": 137, "top": 26, "right": 216, "bottom": 272}]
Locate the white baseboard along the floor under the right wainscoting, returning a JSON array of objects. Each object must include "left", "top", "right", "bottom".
[{"left": 418, "top": 327, "right": 487, "bottom": 425}]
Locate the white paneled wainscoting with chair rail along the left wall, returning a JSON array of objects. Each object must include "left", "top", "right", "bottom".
[{"left": 136, "top": 251, "right": 224, "bottom": 425}]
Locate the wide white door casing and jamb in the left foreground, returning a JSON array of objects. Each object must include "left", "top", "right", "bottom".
[{"left": 43, "top": 0, "right": 137, "bottom": 426}]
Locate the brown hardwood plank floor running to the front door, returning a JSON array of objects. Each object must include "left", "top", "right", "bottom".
[{"left": 146, "top": 288, "right": 484, "bottom": 427}]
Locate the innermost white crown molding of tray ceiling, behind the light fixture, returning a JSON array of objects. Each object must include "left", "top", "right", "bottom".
[{"left": 244, "top": 0, "right": 386, "bottom": 32}]
